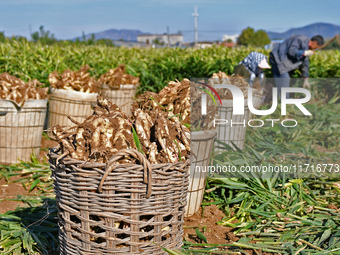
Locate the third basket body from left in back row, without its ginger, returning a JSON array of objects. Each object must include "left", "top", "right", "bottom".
[{"left": 100, "top": 85, "right": 137, "bottom": 114}]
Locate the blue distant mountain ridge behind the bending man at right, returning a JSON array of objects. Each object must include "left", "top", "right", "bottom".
[{"left": 267, "top": 22, "right": 340, "bottom": 40}]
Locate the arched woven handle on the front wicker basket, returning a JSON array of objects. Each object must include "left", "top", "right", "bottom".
[{"left": 98, "top": 149, "right": 152, "bottom": 198}]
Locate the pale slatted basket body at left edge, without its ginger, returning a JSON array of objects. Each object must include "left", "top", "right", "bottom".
[{"left": 0, "top": 100, "right": 47, "bottom": 164}]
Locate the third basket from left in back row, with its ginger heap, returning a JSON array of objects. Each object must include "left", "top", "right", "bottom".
[{"left": 98, "top": 65, "right": 139, "bottom": 114}]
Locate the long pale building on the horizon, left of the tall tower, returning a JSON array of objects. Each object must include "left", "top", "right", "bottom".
[{"left": 137, "top": 34, "right": 183, "bottom": 46}]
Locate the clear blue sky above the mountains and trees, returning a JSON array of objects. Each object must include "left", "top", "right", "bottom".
[{"left": 0, "top": 0, "right": 340, "bottom": 41}]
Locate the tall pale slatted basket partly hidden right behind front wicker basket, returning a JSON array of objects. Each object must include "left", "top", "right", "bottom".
[{"left": 185, "top": 130, "right": 216, "bottom": 217}]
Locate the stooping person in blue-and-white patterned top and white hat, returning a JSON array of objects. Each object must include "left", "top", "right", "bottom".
[{"left": 233, "top": 51, "right": 270, "bottom": 87}]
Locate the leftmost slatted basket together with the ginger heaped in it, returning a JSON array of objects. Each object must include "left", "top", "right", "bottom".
[{"left": 0, "top": 73, "right": 47, "bottom": 164}]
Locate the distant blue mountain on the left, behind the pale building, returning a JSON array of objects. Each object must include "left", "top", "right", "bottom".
[{"left": 75, "top": 29, "right": 150, "bottom": 41}]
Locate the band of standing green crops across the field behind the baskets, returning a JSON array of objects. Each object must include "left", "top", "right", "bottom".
[{"left": 0, "top": 41, "right": 340, "bottom": 94}]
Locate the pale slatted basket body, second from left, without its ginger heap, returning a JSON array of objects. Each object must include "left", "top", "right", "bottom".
[{"left": 48, "top": 88, "right": 98, "bottom": 127}]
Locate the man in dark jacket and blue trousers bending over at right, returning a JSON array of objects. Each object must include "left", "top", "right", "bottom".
[{"left": 269, "top": 35, "right": 324, "bottom": 96}]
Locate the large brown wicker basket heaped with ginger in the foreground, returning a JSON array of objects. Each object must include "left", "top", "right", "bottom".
[{"left": 49, "top": 97, "right": 190, "bottom": 255}]
